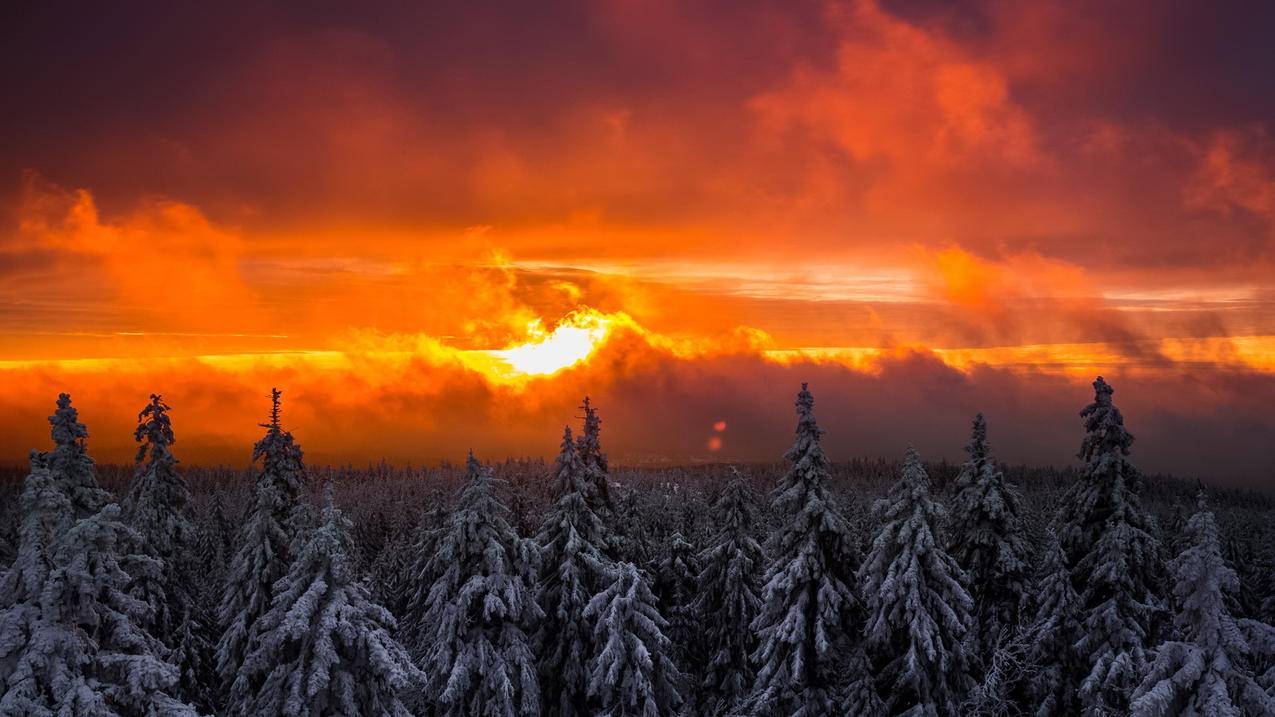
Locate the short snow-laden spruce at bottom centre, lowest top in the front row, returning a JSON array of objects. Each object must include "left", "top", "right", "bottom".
[{"left": 584, "top": 563, "right": 682, "bottom": 717}]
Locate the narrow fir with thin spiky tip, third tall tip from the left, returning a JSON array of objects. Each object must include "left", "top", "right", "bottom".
[{"left": 217, "top": 389, "right": 305, "bottom": 686}]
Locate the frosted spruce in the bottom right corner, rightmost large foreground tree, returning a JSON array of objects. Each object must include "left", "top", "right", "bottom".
[{"left": 1130, "top": 490, "right": 1275, "bottom": 717}]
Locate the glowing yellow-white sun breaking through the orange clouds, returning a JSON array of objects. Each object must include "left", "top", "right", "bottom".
[{"left": 485, "top": 310, "right": 612, "bottom": 376}]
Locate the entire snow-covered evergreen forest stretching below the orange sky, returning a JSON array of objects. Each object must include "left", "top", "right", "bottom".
[{"left": 0, "top": 378, "right": 1275, "bottom": 717}]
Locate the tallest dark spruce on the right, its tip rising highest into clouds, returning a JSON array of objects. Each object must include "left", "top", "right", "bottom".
[{"left": 1054, "top": 376, "right": 1163, "bottom": 714}]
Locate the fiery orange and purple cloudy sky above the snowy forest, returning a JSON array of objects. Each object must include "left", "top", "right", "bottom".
[{"left": 0, "top": 0, "right": 1275, "bottom": 487}]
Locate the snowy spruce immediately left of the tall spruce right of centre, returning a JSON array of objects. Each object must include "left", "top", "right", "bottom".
[{"left": 692, "top": 468, "right": 765, "bottom": 714}]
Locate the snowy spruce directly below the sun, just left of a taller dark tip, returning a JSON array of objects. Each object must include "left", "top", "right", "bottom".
[{"left": 536, "top": 426, "right": 612, "bottom": 717}]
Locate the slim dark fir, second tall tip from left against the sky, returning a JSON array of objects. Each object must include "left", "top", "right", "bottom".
[{"left": 124, "top": 394, "right": 217, "bottom": 711}]
